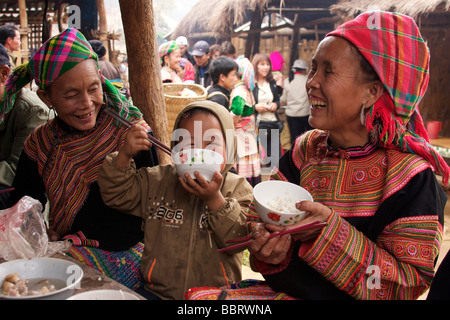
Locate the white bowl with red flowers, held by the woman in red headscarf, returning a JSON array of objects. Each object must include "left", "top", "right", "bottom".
[{"left": 253, "top": 180, "right": 313, "bottom": 226}]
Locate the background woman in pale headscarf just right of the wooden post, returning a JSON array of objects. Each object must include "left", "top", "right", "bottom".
[{"left": 159, "top": 41, "right": 182, "bottom": 83}]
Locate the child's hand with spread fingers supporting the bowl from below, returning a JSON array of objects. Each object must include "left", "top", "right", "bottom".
[{"left": 178, "top": 171, "right": 226, "bottom": 210}]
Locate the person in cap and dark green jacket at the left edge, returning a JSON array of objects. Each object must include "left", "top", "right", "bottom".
[{"left": 0, "top": 44, "right": 50, "bottom": 209}]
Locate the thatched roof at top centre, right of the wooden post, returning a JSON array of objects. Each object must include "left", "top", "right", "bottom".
[{"left": 171, "top": 0, "right": 270, "bottom": 39}]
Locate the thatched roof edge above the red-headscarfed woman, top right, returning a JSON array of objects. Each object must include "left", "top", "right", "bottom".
[{"left": 330, "top": 0, "right": 450, "bottom": 18}]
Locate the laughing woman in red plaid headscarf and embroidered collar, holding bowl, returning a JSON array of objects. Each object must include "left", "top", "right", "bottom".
[{"left": 187, "top": 11, "right": 450, "bottom": 299}]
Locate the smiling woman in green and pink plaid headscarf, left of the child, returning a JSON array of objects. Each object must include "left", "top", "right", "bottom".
[{"left": 6, "top": 29, "right": 158, "bottom": 287}]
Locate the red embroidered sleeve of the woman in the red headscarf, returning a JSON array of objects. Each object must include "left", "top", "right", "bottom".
[{"left": 299, "top": 210, "right": 441, "bottom": 299}]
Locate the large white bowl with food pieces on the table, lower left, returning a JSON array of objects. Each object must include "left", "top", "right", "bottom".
[{"left": 0, "top": 258, "right": 83, "bottom": 300}]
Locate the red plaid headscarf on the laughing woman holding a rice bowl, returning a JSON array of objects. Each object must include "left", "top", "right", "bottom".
[{"left": 327, "top": 11, "right": 450, "bottom": 185}]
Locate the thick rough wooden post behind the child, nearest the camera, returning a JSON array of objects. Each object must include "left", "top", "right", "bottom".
[{"left": 119, "top": 0, "right": 171, "bottom": 163}]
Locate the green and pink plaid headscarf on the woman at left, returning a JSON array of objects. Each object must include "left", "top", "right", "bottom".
[{"left": 0, "top": 28, "right": 142, "bottom": 123}]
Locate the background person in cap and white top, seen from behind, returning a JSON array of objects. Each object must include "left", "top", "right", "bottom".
[{"left": 280, "top": 59, "right": 312, "bottom": 145}]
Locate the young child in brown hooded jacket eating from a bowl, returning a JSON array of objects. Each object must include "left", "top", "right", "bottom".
[{"left": 98, "top": 100, "right": 253, "bottom": 300}]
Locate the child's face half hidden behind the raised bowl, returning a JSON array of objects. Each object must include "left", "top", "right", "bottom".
[{"left": 176, "top": 112, "right": 226, "bottom": 160}]
